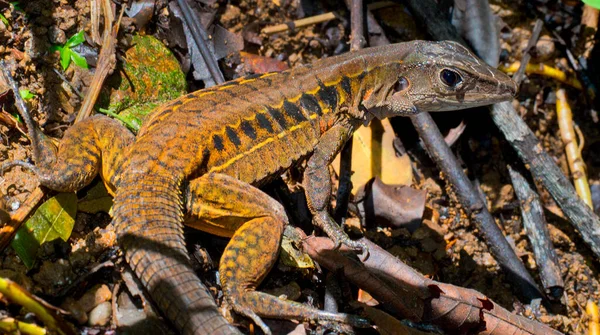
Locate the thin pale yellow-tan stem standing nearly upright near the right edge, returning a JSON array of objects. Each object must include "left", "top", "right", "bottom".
[{"left": 556, "top": 88, "right": 594, "bottom": 208}]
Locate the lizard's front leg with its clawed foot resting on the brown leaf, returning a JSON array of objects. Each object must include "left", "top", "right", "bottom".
[{"left": 303, "top": 123, "right": 368, "bottom": 255}]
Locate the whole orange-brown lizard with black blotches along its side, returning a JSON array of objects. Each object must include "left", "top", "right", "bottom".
[{"left": 0, "top": 41, "right": 516, "bottom": 334}]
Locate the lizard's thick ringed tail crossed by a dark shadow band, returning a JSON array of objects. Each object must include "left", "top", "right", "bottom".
[{"left": 113, "top": 175, "right": 241, "bottom": 335}]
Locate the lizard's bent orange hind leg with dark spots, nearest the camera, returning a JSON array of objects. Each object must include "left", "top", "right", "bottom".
[{"left": 186, "top": 173, "right": 368, "bottom": 334}]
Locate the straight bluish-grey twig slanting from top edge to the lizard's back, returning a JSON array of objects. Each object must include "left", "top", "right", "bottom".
[{"left": 177, "top": 0, "right": 225, "bottom": 85}]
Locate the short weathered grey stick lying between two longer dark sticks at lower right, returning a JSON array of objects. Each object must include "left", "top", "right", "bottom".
[{"left": 507, "top": 165, "right": 564, "bottom": 300}]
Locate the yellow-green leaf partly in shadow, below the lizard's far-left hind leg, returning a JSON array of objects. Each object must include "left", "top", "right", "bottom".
[{"left": 11, "top": 193, "right": 77, "bottom": 267}]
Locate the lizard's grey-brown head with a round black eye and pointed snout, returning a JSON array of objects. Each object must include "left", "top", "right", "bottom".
[{"left": 375, "top": 41, "right": 517, "bottom": 117}]
